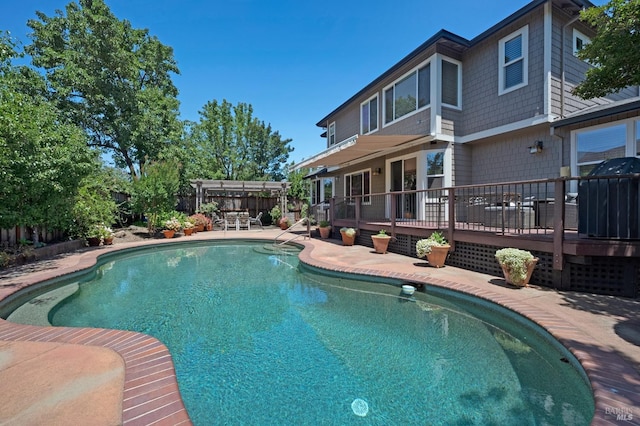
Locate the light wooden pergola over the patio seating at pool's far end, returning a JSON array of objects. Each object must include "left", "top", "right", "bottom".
[{"left": 191, "top": 179, "right": 291, "bottom": 212}]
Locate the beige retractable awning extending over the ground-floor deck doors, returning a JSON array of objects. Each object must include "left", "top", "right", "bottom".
[{"left": 296, "top": 135, "right": 425, "bottom": 168}]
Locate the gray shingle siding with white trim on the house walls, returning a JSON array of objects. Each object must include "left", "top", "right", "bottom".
[{"left": 314, "top": 1, "right": 639, "bottom": 192}]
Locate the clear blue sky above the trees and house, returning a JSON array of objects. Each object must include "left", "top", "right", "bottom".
[{"left": 0, "top": 0, "right": 604, "bottom": 162}]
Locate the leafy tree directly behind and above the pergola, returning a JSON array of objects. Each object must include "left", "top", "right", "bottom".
[{"left": 187, "top": 100, "right": 293, "bottom": 180}]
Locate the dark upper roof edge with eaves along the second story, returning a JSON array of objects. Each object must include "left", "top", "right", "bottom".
[{"left": 316, "top": 0, "right": 594, "bottom": 127}]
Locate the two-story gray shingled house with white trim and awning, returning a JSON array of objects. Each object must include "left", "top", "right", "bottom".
[{"left": 296, "top": 0, "right": 640, "bottom": 216}]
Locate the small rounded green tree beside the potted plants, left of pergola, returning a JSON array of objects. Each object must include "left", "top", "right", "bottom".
[{"left": 131, "top": 160, "right": 180, "bottom": 232}]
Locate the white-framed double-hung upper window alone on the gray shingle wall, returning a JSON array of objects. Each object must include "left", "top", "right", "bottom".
[{"left": 498, "top": 26, "right": 529, "bottom": 95}]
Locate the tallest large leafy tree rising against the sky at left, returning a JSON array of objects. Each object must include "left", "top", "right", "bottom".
[{"left": 26, "top": 0, "right": 180, "bottom": 178}]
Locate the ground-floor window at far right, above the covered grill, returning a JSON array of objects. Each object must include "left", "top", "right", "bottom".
[{"left": 576, "top": 124, "right": 627, "bottom": 176}]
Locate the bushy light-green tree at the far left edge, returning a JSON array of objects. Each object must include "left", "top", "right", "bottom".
[{"left": 0, "top": 32, "right": 99, "bottom": 238}]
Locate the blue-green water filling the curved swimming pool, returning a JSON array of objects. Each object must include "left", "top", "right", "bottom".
[{"left": 40, "top": 243, "right": 594, "bottom": 425}]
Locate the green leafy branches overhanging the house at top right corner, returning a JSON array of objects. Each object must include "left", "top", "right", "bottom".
[{"left": 574, "top": 0, "right": 640, "bottom": 99}]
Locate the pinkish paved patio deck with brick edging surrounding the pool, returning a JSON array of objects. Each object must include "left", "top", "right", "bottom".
[{"left": 0, "top": 228, "right": 640, "bottom": 425}]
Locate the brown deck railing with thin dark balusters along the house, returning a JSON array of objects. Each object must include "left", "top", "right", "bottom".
[{"left": 311, "top": 174, "right": 640, "bottom": 239}]
